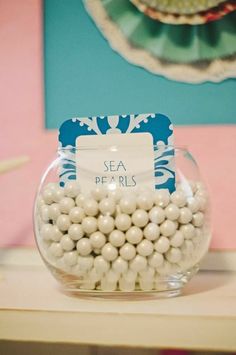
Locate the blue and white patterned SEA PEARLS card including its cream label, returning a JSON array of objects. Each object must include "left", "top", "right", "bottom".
[{"left": 59, "top": 113, "right": 175, "bottom": 192}]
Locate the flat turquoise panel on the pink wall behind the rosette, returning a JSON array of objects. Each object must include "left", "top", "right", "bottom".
[{"left": 44, "top": 0, "right": 236, "bottom": 129}]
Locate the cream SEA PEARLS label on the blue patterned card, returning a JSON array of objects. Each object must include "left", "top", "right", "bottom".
[{"left": 76, "top": 133, "right": 155, "bottom": 193}]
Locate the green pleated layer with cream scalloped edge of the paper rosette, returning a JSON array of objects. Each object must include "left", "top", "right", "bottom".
[{"left": 85, "top": 0, "right": 236, "bottom": 82}]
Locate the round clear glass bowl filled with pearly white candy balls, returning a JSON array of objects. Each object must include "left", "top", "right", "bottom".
[{"left": 34, "top": 146, "right": 211, "bottom": 298}]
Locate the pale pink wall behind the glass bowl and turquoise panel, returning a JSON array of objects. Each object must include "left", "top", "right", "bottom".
[{"left": 0, "top": 0, "right": 236, "bottom": 249}]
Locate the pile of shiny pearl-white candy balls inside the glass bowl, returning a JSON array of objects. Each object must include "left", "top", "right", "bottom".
[{"left": 36, "top": 181, "right": 207, "bottom": 291}]
